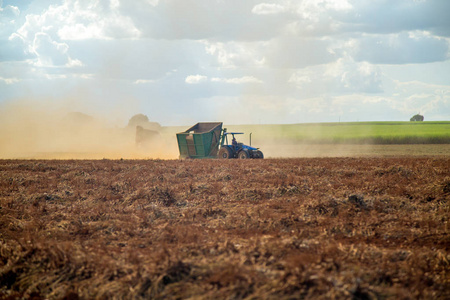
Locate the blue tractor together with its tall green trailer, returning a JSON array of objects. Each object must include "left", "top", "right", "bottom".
[{"left": 177, "top": 122, "right": 264, "bottom": 159}]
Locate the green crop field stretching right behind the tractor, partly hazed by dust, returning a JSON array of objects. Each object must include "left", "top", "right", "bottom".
[{"left": 211, "top": 121, "right": 450, "bottom": 145}]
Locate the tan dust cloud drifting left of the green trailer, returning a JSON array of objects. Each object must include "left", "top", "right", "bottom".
[{"left": 0, "top": 101, "right": 178, "bottom": 159}]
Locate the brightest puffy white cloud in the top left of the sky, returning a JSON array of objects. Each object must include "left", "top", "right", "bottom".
[{"left": 4, "top": 0, "right": 140, "bottom": 67}]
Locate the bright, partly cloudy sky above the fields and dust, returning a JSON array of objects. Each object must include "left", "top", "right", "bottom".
[{"left": 0, "top": 0, "right": 450, "bottom": 126}]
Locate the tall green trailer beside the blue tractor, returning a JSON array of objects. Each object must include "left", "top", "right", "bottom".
[{"left": 177, "top": 122, "right": 223, "bottom": 158}]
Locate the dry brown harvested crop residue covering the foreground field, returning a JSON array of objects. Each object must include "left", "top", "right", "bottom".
[{"left": 0, "top": 157, "right": 450, "bottom": 299}]
